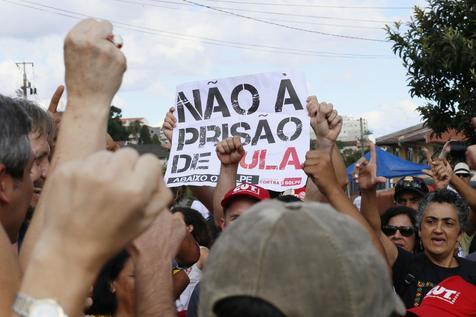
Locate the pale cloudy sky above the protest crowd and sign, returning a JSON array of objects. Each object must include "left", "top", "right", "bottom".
[{"left": 0, "top": 0, "right": 424, "bottom": 126}]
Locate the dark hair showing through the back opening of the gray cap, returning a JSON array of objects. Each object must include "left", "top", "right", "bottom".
[{"left": 213, "top": 296, "right": 286, "bottom": 317}]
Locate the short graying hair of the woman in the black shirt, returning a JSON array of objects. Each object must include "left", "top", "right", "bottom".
[{"left": 416, "top": 189, "right": 469, "bottom": 229}]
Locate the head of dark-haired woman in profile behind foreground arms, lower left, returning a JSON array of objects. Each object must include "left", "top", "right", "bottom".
[{"left": 86, "top": 250, "right": 134, "bottom": 315}]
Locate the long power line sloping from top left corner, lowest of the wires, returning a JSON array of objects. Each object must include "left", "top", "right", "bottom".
[{"left": 2, "top": 0, "right": 392, "bottom": 59}]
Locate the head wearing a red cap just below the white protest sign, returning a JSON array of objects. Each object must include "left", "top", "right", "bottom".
[{"left": 221, "top": 183, "right": 270, "bottom": 230}]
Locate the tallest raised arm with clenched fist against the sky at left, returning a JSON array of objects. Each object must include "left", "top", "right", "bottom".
[{"left": 20, "top": 19, "right": 126, "bottom": 268}]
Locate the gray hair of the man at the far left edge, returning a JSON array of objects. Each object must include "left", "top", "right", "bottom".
[{"left": 0, "top": 95, "right": 32, "bottom": 179}]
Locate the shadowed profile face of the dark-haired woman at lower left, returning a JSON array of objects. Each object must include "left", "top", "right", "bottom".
[{"left": 113, "top": 258, "right": 135, "bottom": 311}]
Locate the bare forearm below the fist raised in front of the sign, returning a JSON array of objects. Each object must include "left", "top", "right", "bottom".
[{"left": 213, "top": 164, "right": 238, "bottom": 226}]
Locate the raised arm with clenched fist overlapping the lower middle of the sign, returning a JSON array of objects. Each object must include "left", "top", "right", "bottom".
[{"left": 213, "top": 136, "right": 245, "bottom": 227}]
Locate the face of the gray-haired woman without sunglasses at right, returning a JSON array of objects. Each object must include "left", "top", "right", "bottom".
[{"left": 420, "top": 202, "right": 461, "bottom": 259}]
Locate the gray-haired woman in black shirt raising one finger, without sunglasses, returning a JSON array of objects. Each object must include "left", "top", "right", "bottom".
[{"left": 353, "top": 144, "right": 476, "bottom": 308}]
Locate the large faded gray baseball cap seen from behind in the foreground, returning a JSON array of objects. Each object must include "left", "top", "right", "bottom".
[{"left": 200, "top": 200, "right": 405, "bottom": 317}]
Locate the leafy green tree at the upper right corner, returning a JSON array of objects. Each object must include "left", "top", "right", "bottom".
[{"left": 386, "top": 0, "right": 476, "bottom": 136}]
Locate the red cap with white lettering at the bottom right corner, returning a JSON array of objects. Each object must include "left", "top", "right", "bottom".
[{"left": 407, "top": 275, "right": 476, "bottom": 317}]
